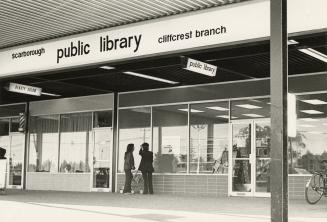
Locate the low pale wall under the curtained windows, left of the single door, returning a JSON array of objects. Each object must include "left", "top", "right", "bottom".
[{"left": 26, "top": 172, "right": 91, "bottom": 192}]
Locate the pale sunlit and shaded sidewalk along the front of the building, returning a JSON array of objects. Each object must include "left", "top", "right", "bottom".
[{"left": 0, "top": 191, "right": 327, "bottom": 222}]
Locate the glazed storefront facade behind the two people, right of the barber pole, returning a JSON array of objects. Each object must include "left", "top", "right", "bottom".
[{"left": 16, "top": 74, "right": 327, "bottom": 198}]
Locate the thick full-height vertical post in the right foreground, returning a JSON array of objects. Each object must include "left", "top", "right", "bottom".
[{"left": 270, "top": 0, "right": 288, "bottom": 222}]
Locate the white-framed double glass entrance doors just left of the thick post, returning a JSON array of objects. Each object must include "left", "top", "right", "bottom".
[{"left": 229, "top": 119, "right": 271, "bottom": 197}]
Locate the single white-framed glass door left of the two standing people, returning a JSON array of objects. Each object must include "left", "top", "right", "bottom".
[{"left": 92, "top": 128, "right": 112, "bottom": 192}]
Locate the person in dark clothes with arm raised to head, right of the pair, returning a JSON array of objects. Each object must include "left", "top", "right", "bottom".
[{"left": 139, "top": 143, "right": 154, "bottom": 194}]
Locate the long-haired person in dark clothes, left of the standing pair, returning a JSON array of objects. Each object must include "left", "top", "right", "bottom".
[{"left": 123, "top": 143, "right": 135, "bottom": 193}]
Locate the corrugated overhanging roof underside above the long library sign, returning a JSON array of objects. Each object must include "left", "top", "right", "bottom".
[{"left": 0, "top": 0, "right": 246, "bottom": 49}]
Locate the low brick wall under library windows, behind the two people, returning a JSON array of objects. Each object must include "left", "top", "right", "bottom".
[{"left": 117, "top": 174, "right": 228, "bottom": 197}]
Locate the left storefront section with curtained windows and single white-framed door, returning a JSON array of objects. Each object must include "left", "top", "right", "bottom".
[{"left": 26, "top": 94, "right": 114, "bottom": 191}]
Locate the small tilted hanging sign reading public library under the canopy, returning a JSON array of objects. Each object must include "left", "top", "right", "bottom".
[{"left": 184, "top": 58, "right": 217, "bottom": 76}]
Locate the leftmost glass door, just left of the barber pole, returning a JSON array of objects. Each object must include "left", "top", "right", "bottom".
[{"left": 7, "top": 133, "right": 25, "bottom": 189}]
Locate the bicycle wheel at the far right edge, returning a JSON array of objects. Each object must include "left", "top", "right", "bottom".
[{"left": 305, "top": 174, "right": 324, "bottom": 204}]
